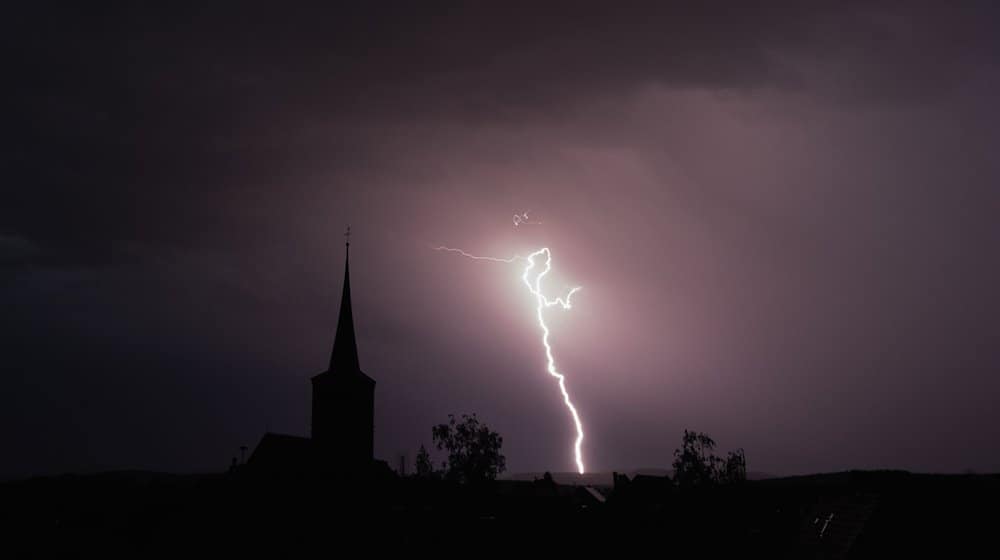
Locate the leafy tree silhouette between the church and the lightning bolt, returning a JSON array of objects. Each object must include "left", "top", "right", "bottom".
[{"left": 431, "top": 414, "right": 507, "bottom": 483}]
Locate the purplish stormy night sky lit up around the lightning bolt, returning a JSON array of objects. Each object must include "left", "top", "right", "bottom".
[{"left": 0, "top": 1, "right": 1000, "bottom": 477}]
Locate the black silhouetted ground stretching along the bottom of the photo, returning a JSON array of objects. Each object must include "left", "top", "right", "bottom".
[{"left": 0, "top": 471, "right": 1000, "bottom": 558}]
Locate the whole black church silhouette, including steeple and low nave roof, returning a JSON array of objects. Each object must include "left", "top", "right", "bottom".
[{"left": 247, "top": 238, "right": 375, "bottom": 476}]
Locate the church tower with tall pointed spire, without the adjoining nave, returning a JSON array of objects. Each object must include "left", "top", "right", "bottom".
[{"left": 312, "top": 234, "right": 375, "bottom": 469}]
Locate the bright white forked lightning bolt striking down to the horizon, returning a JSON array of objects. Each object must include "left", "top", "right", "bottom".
[{"left": 434, "top": 246, "right": 585, "bottom": 474}]
